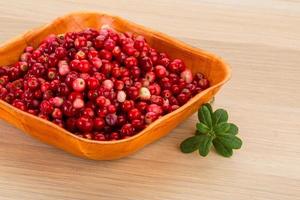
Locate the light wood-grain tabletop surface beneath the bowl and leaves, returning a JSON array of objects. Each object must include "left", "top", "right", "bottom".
[{"left": 0, "top": 0, "right": 300, "bottom": 200}]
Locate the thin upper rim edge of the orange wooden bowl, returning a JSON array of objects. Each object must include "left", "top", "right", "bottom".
[{"left": 0, "top": 11, "right": 231, "bottom": 145}]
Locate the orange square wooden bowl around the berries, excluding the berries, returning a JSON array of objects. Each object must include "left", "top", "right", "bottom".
[{"left": 0, "top": 12, "right": 230, "bottom": 160}]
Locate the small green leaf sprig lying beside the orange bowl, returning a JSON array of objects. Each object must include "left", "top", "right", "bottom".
[{"left": 180, "top": 103, "right": 242, "bottom": 157}]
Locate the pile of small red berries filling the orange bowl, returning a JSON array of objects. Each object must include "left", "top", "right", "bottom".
[{"left": 0, "top": 27, "right": 209, "bottom": 141}]
